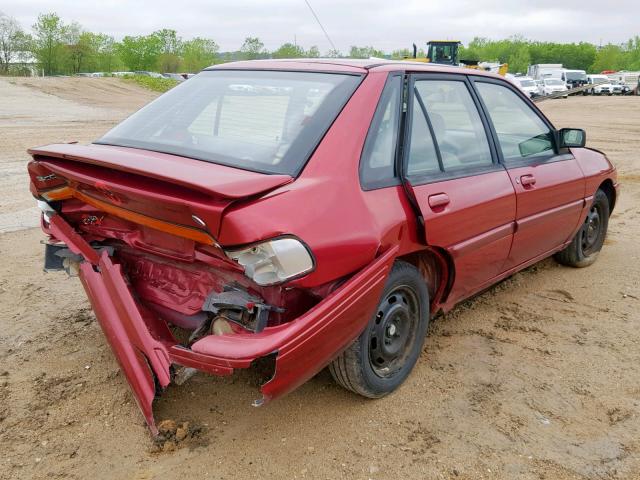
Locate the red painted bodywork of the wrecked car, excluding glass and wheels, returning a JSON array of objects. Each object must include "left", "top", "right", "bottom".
[{"left": 29, "top": 61, "right": 618, "bottom": 433}]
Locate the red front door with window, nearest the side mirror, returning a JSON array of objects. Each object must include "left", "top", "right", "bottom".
[{"left": 474, "top": 77, "right": 585, "bottom": 269}]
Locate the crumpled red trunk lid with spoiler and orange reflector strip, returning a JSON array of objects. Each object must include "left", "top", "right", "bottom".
[{"left": 29, "top": 144, "right": 292, "bottom": 243}]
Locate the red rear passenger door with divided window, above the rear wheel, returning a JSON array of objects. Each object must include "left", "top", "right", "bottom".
[{"left": 403, "top": 74, "right": 516, "bottom": 302}]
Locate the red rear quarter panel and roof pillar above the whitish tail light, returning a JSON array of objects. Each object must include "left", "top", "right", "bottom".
[{"left": 219, "top": 72, "right": 406, "bottom": 287}]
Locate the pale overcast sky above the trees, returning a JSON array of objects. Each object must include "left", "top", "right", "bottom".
[{"left": 0, "top": 0, "right": 640, "bottom": 53}]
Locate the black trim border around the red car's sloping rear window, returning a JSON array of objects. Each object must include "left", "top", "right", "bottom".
[{"left": 91, "top": 68, "right": 368, "bottom": 179}]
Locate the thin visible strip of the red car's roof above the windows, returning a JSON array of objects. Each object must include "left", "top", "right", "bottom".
[{"left": 205, "top": 58, "right": 504, "bottom": 78}]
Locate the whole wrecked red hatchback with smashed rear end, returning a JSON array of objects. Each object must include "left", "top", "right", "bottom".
[{"left": 28, "top": 60, "right": 618, "bottom": 434}]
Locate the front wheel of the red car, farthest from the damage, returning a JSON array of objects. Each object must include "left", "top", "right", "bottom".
[{"left": 554, "top": 190, "right": 610, "bottom": 268}]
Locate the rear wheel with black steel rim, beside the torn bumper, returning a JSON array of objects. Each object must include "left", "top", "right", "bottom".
[{"left": 329, "top": 261, "right": 429, "bottom": 398}]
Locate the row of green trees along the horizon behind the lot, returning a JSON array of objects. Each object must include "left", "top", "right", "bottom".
[{"left": 0, "top": 12, "right": 640, "bottom": 75}]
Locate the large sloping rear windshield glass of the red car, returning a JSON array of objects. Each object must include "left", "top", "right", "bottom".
[{"left": 95, "top": 70, "right": 361, "bottom": 176}]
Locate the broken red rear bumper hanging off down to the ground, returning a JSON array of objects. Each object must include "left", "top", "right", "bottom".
[{"left": 51, "top": 215, "right": 397, "bottom": 435}]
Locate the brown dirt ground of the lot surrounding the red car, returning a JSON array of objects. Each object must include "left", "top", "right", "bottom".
[{"left": 0, "top": 79, "right": 640, "bottom": 480}]
